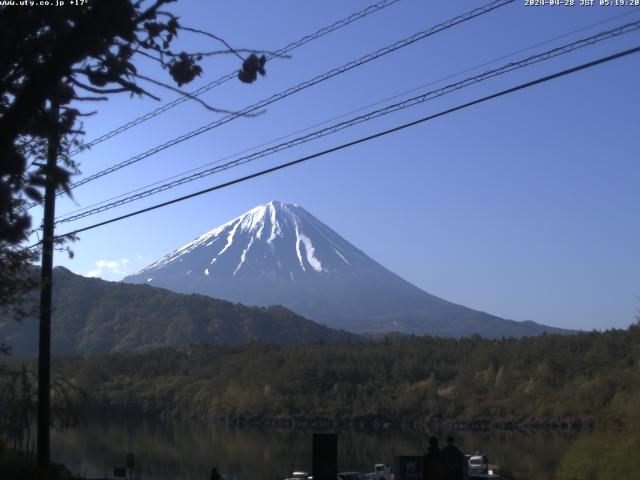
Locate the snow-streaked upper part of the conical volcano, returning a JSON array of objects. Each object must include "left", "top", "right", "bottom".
[{"left": 134, "top": 200, "right": 362, "bottom": 282}]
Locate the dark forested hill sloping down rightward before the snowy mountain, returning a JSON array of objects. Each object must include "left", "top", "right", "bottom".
[{"left": 0, "top": 267, "right": 361, "bottom": 356}]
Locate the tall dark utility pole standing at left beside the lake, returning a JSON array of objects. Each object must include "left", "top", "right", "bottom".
[{"left": 38, "top": 102, "right": 60, "bottom": 480}]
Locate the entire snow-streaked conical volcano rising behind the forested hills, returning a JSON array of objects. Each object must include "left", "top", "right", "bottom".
[{"left": 123, "top": 201, "right": 566, "bottom": 338}]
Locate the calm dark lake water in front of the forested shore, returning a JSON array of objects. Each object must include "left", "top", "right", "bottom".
[{"left": 51, "top": 420, "right": 576, "bottom": 480}]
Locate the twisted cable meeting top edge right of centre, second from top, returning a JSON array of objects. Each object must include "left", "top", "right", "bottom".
[{"left": 25, "top": 0, "right": 514, "bottom": 210}]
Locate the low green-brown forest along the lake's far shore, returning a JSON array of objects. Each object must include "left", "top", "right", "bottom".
[{"left": 48, "top": 327, "right": 640, "bottom": 426}]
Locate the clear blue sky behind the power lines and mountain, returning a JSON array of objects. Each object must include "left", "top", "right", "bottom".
[{"left": 31, "top": 0, "right": 640, "bottom": 329}]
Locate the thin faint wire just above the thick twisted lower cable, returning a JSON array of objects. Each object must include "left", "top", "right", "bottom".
[{"left": 53, "top": 10, "right": 638, "bottom": 221}]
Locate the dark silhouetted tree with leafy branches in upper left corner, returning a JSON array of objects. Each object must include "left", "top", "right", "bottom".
[{"left": 0, "top": 0, "right": 265, "bottom": 248}]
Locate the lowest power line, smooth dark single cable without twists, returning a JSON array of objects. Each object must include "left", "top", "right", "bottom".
[{"left": 36, "top": 46, "right": 640, "bottom": 248}]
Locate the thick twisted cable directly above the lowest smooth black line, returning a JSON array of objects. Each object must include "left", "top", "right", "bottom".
[{"left": 51, "top": 21, "right": 640, "bottom": 225}]
